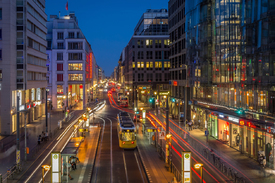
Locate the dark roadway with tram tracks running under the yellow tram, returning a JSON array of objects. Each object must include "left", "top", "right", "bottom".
[{"left": 91, "top": 93, "right": 146, "bottom": 183}]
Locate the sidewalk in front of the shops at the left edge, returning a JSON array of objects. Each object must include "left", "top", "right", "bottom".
[{"left": 0, "top": 101, "right": 98, "bottom": 175}]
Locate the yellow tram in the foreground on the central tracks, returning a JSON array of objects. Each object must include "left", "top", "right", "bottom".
[{"left": 117, "top": 112, "right": 137, "bottom": 149}]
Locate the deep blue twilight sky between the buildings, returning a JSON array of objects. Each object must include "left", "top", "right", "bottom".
[{"left": 46, "top": 0, "right": 169, "bottom": 76}]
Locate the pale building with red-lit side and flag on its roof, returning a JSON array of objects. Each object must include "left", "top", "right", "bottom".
[{"left": 47, "top": 13, "right": 96, "bottom": 110}]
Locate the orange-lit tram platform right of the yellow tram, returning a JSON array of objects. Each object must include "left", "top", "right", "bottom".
[{"left": 137, "top": 123, "right": 174, "bottom": 183}]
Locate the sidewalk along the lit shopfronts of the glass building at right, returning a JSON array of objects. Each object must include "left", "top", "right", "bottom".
[{"left": 139, "top": 100, "right": 275, "bottom": 182}]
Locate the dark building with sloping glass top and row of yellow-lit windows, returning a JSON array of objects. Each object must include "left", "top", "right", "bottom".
[{"left": 123, "top": 9, "right": 170, "bottom": 106}]
